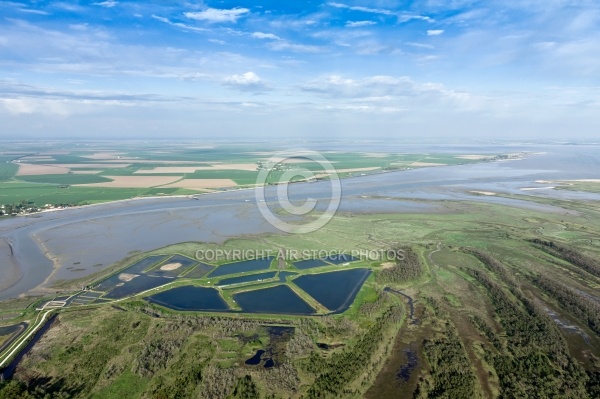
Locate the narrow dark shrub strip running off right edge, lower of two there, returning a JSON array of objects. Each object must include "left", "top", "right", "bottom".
[{"left": 532, "top": 275, "right": 600, "bottom": 335}]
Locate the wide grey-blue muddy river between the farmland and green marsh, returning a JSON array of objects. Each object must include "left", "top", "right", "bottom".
[{"left": 0, "top": 144, "right": 600, "bottom": 300}]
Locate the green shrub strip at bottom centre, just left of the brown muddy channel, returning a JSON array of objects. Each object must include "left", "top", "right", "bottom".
[{"left": 303, "top": 306, "right": 402, "bottom": 399}]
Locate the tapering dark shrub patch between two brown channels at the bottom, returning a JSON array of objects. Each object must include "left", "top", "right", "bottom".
[{"left": 413, "top": 299, "right": 475, "bottom": 399}]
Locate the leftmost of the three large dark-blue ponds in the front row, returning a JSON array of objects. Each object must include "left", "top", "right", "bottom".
[{"left": 146, "top": 285, "right": 229, "bottom": 312}]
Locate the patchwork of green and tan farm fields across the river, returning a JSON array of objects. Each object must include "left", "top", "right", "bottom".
[{"left": 0, "top": 142, "right": 523, "bottom": 207}]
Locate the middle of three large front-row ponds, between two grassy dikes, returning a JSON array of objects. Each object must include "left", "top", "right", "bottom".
[{"left": 233, "top": 285, "right": 315, "bottom": 315}]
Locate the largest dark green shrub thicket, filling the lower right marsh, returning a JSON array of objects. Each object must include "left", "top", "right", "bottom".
[{"left": 463, "top": 269, "right": 590, "bottom": 398}]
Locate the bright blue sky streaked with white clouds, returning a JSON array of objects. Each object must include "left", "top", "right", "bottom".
[{"left": 0, "top": 0, "right": 600, "bottom": 139}]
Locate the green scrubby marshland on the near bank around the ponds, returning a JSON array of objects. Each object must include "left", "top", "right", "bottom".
[{"left": 0, "top": 200, "right": 600, "bottom": 398}]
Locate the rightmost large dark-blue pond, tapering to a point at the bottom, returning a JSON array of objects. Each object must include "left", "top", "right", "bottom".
[{"left": 293, "top": 269, "right": 371, "bottom": 313}]
